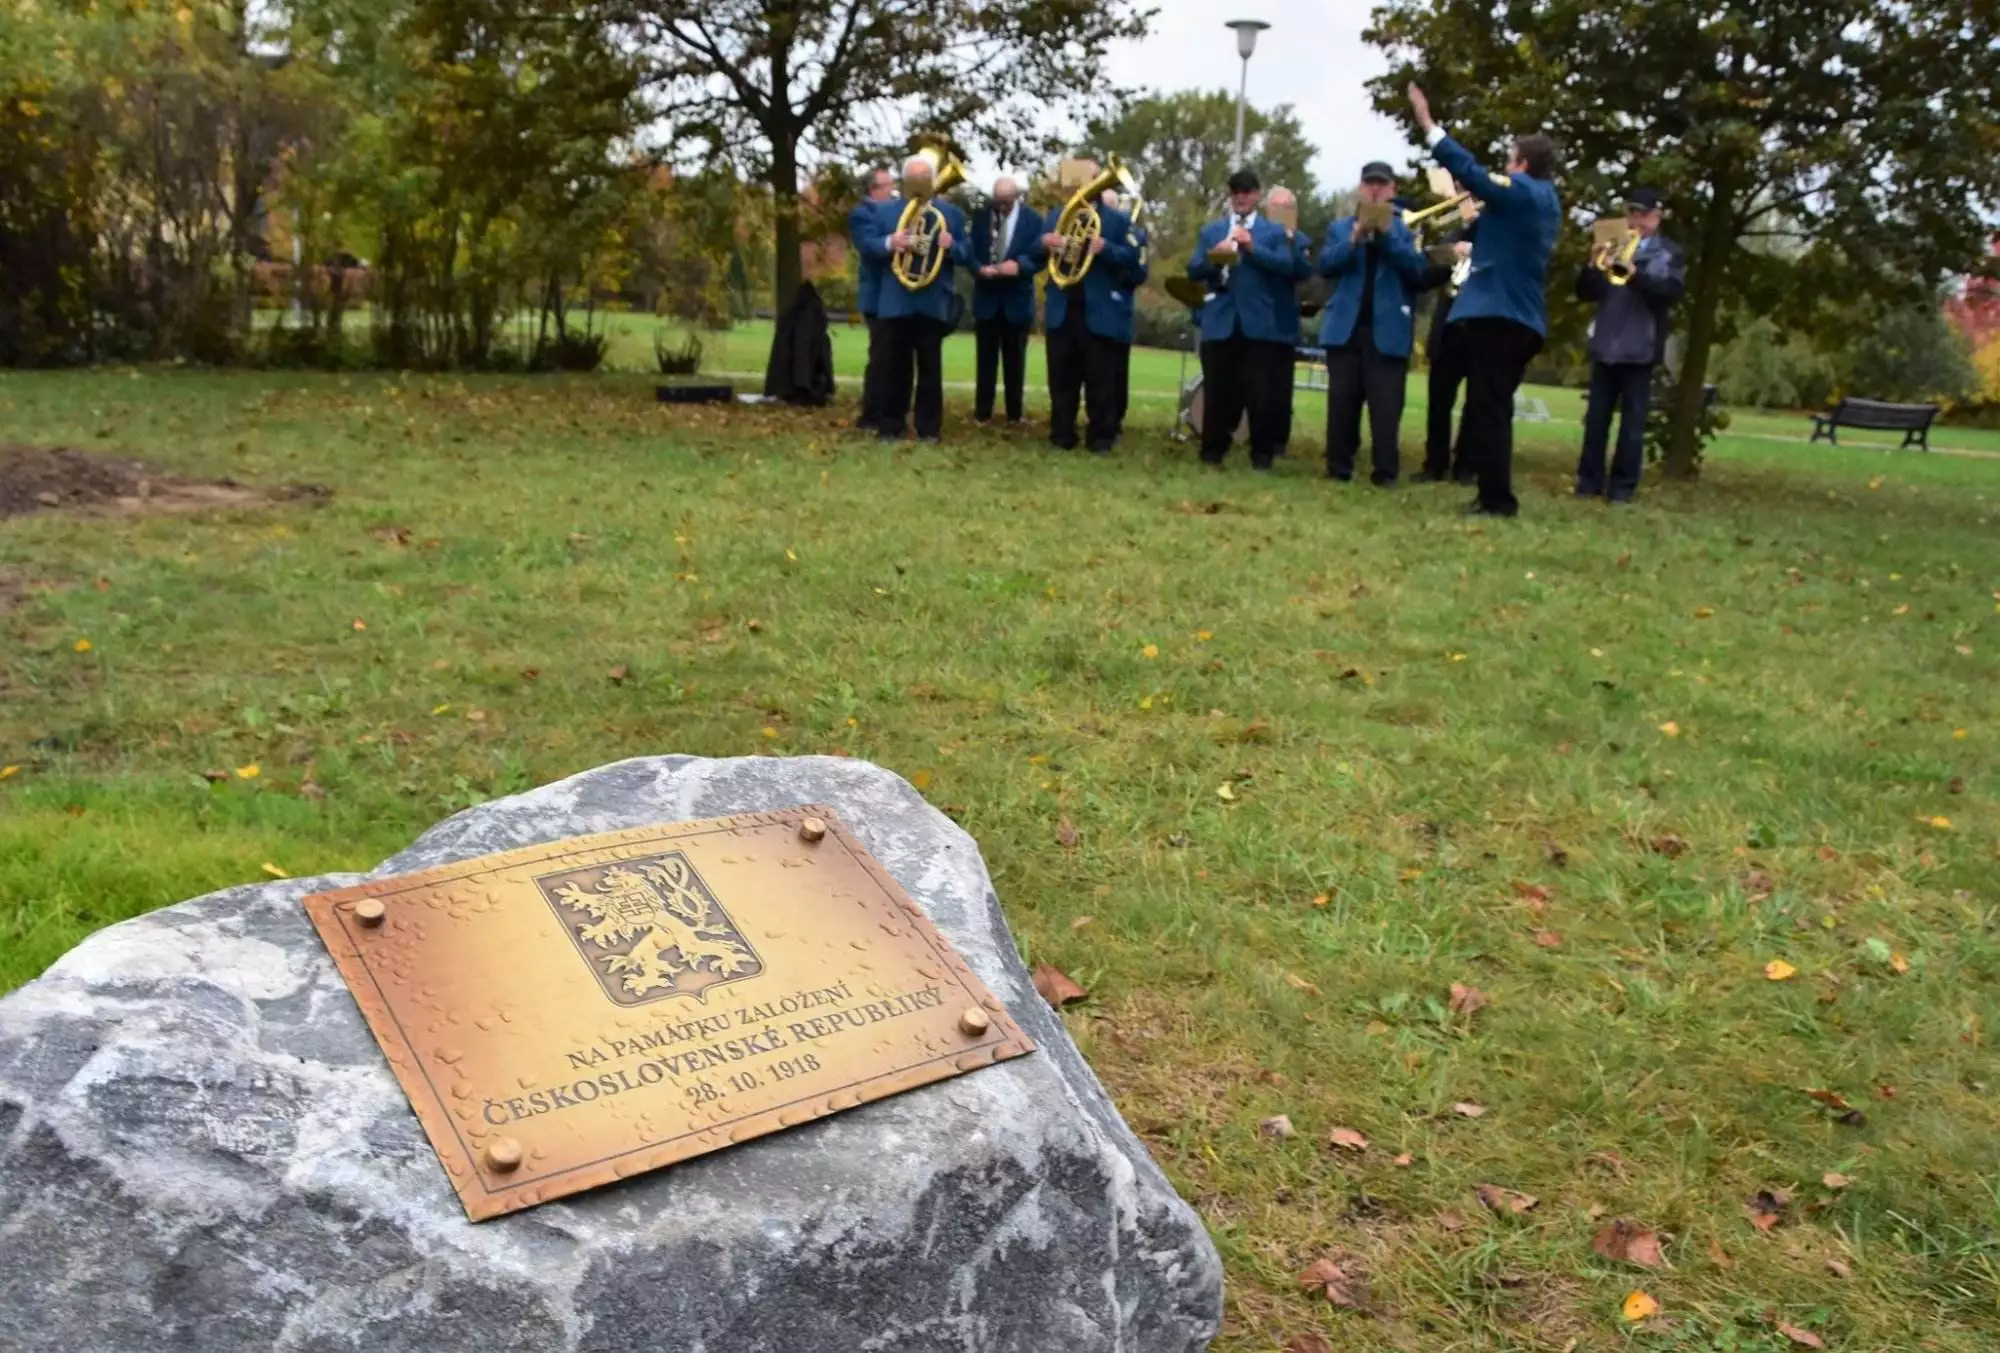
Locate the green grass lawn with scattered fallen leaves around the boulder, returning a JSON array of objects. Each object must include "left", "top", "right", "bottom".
[{"left": 0, "top": 362, "right": 2000, "bottom": 1353}]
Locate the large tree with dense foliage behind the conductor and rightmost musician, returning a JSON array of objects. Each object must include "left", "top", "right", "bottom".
[{"left": 1366, "top": 0, "right": 2000, "bottom": 476}]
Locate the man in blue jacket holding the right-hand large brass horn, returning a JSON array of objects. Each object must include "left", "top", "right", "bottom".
[{"left": 1034, "top": 206, "right": 1146, "bottom": 456}]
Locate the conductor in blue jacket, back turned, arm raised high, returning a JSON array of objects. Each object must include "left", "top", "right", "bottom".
[{"left": 1410, "top": 84, "right": 1562, "bottom": 516}]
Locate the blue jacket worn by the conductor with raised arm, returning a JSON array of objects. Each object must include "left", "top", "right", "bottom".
[{"left": 1430, "top": 136, "right": 1562, "bottom": 336}]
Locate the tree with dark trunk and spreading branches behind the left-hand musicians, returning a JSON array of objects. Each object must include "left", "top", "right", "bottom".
[{"left": 622, "top": 0, "right": 1148, "bottom": 308}]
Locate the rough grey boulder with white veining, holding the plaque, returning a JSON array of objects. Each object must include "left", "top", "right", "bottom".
[{"left": 0, "top": 757, "right": 1222, "bottom": 1353}]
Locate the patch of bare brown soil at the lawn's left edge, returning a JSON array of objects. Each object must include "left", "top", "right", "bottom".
[{"left": 0, "top": 446, "right": 332, "bottom": 516}]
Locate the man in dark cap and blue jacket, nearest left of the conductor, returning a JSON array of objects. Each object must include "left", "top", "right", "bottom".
[{"left": 1320, "top": 160, "right": 1424, "bottom": 488}]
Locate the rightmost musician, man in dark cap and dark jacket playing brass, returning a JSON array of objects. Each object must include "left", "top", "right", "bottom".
[{"left": 1576, "top": 188, "right": 1688, "bottom": 502}]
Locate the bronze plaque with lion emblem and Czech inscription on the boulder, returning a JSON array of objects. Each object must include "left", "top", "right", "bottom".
[{"left": 306, "top": 807, "right": 1034, "bottom": 1221}]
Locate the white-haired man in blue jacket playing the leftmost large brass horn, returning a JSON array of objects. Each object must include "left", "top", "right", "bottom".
[{"left": 868, "top": 156, "right": 972, "bottom": 442}]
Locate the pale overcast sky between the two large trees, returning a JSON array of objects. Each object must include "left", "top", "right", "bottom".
[{"left": 1106, "top": 0, "right": 1412, "bottom": 188}]
